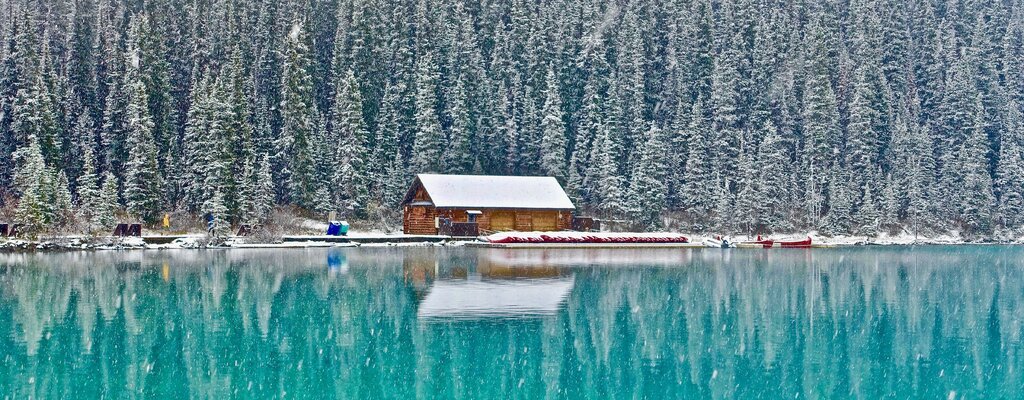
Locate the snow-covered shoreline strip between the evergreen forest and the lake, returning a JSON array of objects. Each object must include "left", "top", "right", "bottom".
[{"left": 0, "top": 232, "right": 1024, "bottom": 252}]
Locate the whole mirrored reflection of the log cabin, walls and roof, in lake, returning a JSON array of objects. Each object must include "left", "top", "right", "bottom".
[{"left": 402, "top": 251, "right": 574, "bottom": 322}]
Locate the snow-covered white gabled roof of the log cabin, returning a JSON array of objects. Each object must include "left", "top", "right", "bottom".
[{"left": 403, "top": 174, "right": 575, "bottom": 210}]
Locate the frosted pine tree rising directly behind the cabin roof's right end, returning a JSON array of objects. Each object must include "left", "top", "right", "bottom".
[{"left": 541, "top": 68, "right": 566, "bottom": 182}]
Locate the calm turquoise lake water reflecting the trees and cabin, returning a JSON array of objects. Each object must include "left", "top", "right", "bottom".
[{"left": 0, "top": 247, "right": 1024, "bottom": 399}]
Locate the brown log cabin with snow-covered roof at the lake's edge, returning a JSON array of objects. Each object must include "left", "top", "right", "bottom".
[{"left": 401, "top": 174, "right": 575, "bottom": 234}]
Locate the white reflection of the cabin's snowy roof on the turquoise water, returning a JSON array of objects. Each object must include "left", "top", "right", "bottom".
[{"left": 418, "top": 276, "right": 573, "bottom": 319}]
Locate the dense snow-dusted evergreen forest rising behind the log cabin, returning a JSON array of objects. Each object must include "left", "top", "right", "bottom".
[{"left": 0, "top": 0, "right": 1024, "bottom": 236}]
